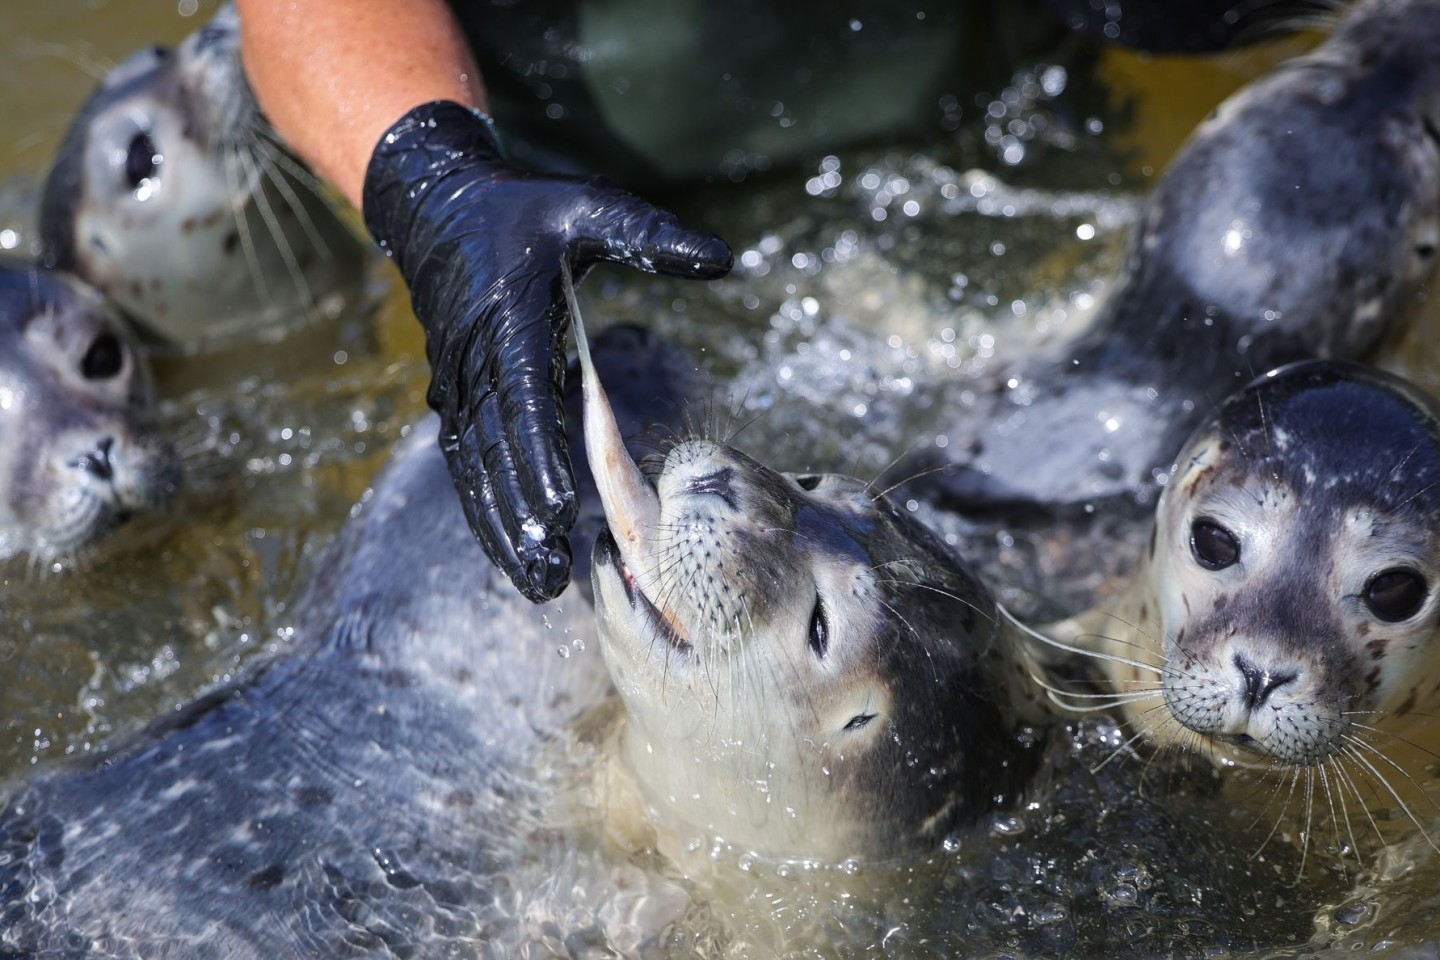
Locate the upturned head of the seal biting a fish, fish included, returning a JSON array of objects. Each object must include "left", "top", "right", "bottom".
[{"left": 570, "top": 277, "right": 1028, "bottom": 862}]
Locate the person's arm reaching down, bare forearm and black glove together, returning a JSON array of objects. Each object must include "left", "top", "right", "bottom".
[{"left": 240, "top": 0, "right": 730, "bottom": 600}]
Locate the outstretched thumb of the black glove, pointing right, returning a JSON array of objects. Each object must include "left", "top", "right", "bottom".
[{"left": 572, "top": 183, "right": 734, "bottom": 279}]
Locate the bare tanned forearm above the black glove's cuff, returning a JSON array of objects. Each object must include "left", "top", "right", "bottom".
[{"left": 238, "top": 0, "right": 485, "bottom": 207}]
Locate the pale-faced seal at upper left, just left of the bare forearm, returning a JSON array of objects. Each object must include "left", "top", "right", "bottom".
[{"left": 39, "top": 6, "right": 366, "bottom": 350}]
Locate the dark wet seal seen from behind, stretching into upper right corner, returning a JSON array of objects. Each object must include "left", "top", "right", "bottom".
[{"left": 901, "top": 0, "right": 1440, "bottom": 619}]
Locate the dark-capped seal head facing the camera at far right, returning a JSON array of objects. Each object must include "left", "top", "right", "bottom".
[{"left": 1041, "top": 361, "right": 1440, "bottom": 800}]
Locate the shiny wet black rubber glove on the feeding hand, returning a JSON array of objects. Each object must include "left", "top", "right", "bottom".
[{"left": 363, "top": 101, "right": 730, "bottom": 603}]
